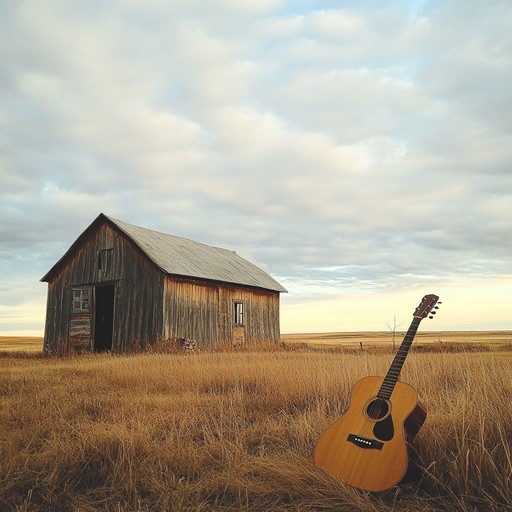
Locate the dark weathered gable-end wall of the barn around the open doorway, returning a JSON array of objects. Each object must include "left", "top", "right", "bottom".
[{"left": 45, "top": 225, "right": 163, "bottom": 352}]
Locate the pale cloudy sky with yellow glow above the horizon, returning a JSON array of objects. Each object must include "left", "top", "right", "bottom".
[{"left": 0, "top": 0, "right": 512, "bottom": 335}]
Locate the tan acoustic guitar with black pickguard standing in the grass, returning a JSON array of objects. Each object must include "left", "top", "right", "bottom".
[{"left": 315, "top": 295, "right": 440, "bottom": 492}]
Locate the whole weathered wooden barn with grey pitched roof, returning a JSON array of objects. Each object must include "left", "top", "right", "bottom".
[{"left": 41, "top": 214, "right": 286, "bottom": 353}]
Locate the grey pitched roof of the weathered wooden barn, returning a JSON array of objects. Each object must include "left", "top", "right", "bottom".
[{"left": 42, "top": 214, "right": 286, "bottom": 292}]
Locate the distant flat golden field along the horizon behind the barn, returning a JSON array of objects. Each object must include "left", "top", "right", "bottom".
[{"left": 0, "top": 331, "right": 512, "bottom": 352}]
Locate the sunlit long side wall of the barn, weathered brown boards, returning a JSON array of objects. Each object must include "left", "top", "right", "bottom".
[{"left": 163, "top": 276, "right": 279, "bottom": 345}]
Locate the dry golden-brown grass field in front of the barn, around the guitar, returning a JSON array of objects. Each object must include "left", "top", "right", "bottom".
[{"left": 0, "top": 333, "right": 512, "bottom": 512}]
